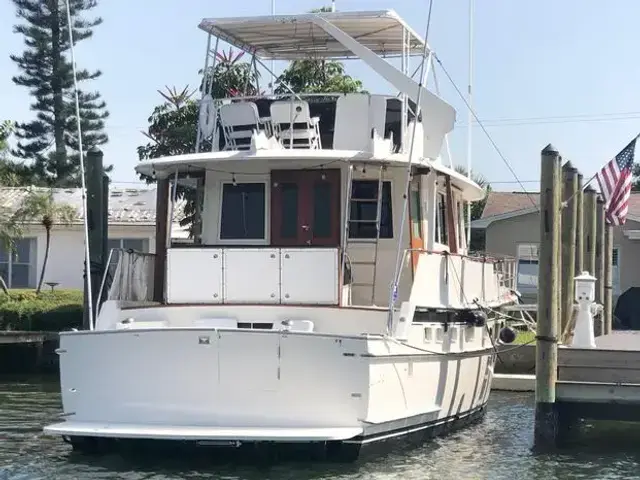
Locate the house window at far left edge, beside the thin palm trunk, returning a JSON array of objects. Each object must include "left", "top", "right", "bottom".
[{"left": 0, "top": 238, "right": 37, "bottom": 288}]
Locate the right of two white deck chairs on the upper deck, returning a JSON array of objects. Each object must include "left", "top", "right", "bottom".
[{"left": 270, "top": 100, "right": 322, "bottom": 149}]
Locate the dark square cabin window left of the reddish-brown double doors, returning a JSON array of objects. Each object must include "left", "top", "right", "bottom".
[{"left": 220, "top": 182, "right": 265, "bottom": 240}]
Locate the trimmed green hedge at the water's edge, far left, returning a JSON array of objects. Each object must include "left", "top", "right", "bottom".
[{"left": 0, "top": 290, "right": 82, "bottom": 332}]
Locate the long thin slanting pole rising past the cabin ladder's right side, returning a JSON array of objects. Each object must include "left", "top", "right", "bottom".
[{"left": 378, "top": 0, "right": 433, "bottom": 335}]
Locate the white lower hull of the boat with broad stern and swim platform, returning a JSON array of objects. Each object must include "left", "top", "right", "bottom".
[{"left": 45, "top": 322, "right": 495, "bottom": 460}]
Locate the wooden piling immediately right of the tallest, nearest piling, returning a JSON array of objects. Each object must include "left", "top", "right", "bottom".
[{"left": 560, "top": 162, "right": 578, "bottom": 333}]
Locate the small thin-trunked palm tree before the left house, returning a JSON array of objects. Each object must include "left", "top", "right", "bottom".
[{"left": 9, "top": 188, "right": 78, "bottom": 294}]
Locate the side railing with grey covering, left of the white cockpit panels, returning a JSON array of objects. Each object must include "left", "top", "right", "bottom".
[{"left": 97, "top": 248, "right": 155, "bottom": 305}]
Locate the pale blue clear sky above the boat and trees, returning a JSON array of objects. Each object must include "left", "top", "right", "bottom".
[{"left": 0, "top": 0, "right": 640, "bottom": 191}]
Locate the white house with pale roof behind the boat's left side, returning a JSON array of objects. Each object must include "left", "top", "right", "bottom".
[{"left": 0, "top": 187, "right": 183, "bottom": 288}]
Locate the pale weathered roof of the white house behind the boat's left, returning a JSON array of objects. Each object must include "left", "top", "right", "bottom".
[{"left": 0, "top": 186, "right": 182, "bottom": 225}]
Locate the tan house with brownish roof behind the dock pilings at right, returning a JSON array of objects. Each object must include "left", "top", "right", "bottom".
[{"left": 471, "top": 192, "right": 624, "bottom": 303}]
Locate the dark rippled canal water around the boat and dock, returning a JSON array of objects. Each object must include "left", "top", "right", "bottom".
[{"left": 0, "top": 379, "right": 640, "bottom": 480}]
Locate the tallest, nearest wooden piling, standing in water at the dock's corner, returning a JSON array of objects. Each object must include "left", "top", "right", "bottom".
[{"left": 534, "top": 144, "right": 560, "bottom": 448}]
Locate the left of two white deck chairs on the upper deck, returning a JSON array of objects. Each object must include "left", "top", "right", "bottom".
[{"left": 220, "top": 102, "right": 260, "bottom": 150}]
